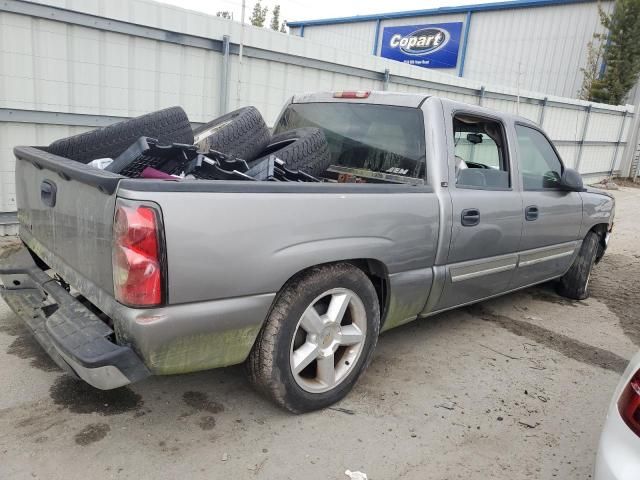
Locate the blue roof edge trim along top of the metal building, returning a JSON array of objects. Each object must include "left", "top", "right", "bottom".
[{"left": 287, "top": 0, "right": 606, "bottom": 28}]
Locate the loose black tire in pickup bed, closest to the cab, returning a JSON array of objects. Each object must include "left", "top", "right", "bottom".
[{"left": 249, "top": 127, "right": 331, "bottom": 176}]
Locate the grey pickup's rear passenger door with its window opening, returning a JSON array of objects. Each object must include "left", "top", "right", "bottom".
[{"left": 435, "top": 107, "right": 523, "bottom": 310}]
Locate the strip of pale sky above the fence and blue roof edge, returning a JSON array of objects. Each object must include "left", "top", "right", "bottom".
[{"left": 152, "top": 0, "right": 488, "bottom": 21}]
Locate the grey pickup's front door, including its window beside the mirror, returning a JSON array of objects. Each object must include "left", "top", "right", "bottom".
[{"left": 511, "top": 124, "right": 582, "bottom": 288}]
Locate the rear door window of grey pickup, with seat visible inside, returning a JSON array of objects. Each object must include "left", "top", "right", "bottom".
[{"left": 453, "top": 114, "right": 511, "bottom": 190}]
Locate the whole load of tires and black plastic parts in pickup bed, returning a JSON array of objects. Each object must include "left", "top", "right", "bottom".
[{"left": 55, "top": 107, "right": 330, "bottom": 182}]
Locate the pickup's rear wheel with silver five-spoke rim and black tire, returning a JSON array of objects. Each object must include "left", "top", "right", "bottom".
[{"left": 247, "top": 263, "right": 380, "bottom": 413}]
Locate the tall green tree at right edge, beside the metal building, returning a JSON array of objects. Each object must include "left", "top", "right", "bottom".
[{"left": 589, "top": 0, "right": 640, "bottom": 105}]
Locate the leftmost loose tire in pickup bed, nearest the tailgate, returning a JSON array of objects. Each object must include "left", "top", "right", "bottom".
[{"left": 46, "top": 107, "right": 193, "bottom": 163}]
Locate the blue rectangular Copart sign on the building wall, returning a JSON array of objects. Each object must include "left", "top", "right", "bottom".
[{"left": 380, "top": 22, "right": 462, "bottom": 68}]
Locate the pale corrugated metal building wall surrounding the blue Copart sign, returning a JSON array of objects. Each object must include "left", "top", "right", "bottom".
[{"left": 292, "top": 1, "right": 613, "bottom": 97}]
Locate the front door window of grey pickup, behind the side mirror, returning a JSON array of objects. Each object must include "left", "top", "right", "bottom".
[{"left": 516, "top": 125, "right": 562, "bottom": 190}]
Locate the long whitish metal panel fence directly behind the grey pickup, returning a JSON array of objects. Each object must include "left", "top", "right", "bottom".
[{"left": 0, "top": 0, "right": 633, "bottom": 233}]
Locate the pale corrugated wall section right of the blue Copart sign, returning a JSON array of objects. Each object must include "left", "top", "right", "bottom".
[{"left": 464, "top": 2, "right": 610, "bottom": 97}]
